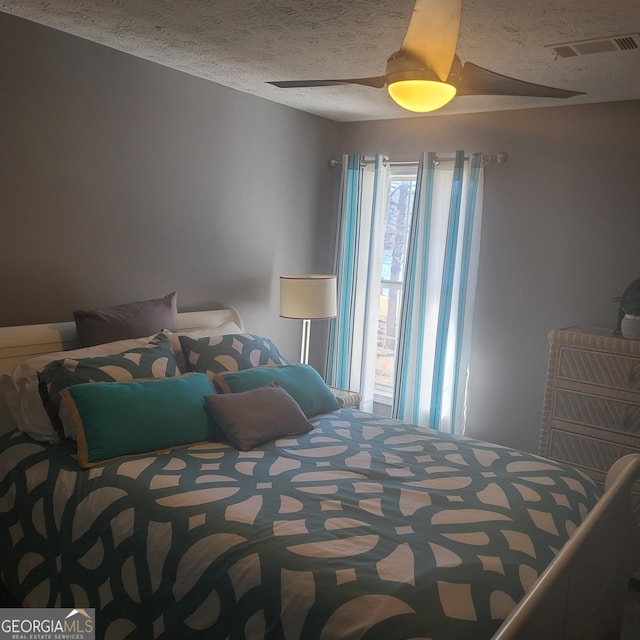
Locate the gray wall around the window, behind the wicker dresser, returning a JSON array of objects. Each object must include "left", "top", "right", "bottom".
[{"left": 343, "top": 102, "right": 640, "bottom": 451}]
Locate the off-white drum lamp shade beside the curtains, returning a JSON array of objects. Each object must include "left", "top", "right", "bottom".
[{"left": 280, "top": 273, "right": 337, "bottom": 320}]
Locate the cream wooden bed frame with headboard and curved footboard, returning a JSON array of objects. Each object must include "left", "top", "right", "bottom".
[{"left": 0, "top": 308, "right": 640, "bottom": 640}]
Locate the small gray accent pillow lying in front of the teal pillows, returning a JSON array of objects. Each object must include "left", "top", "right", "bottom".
[{"left": 204, "top": 386, "right": 313, "bottom": 451}]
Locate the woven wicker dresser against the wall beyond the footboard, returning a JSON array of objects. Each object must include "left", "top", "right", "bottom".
[{"left": 539, "top": 327, "right": 640, "bottom": 521}]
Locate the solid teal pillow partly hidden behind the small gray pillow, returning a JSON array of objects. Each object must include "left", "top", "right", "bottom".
[{"left": 213, "top": 364, "right": 340, "bottom": 418}]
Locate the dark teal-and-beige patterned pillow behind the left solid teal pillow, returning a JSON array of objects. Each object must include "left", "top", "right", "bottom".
[{"left": 38, "top": 333, "right": 179, "bottom": 438}]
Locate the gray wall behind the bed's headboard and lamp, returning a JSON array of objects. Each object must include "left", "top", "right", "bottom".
[{"left": 0, "top": 13, "right": 339, "bottom": 357}]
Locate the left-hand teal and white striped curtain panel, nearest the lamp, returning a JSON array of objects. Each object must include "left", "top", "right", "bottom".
[{"left": 326, "top": 155, "right": 389, "bottom": 410}]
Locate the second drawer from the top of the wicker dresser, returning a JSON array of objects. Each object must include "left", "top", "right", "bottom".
[{"left": 551, "top": 389, "right": 640, "bottom": 432}]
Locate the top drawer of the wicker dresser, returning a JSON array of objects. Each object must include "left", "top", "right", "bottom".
[{"left": 557, "top": 346, "right": 640, "bottom": 392}]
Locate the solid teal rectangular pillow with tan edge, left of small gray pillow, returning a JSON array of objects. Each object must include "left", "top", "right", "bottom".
[{"left": 61, "top": 373, "right": 213, "bottom": 467}]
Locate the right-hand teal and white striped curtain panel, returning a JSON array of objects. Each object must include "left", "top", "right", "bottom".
[{"left": 393, "top": 151, "right": 483, "bottom": 433}]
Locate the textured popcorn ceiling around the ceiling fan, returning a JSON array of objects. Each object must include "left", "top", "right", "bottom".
[{"left": 0, "top": 0, "right": 640, "bottom": 121}]
